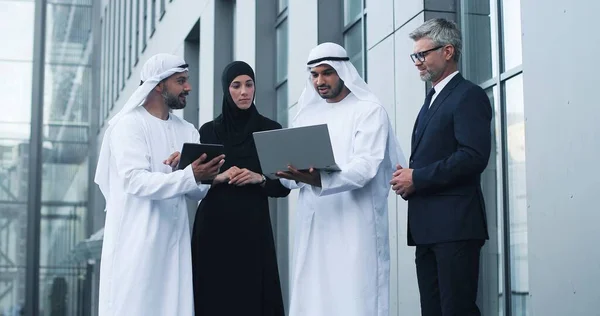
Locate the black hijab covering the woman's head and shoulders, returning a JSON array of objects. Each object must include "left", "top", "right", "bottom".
[{"left": 215, "top": 61, "right": 261, "bottom": 157}]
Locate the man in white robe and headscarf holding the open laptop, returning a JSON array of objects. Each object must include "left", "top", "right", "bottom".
[{"left": 278, "top": 43, "right": 405, "bottom": 316}]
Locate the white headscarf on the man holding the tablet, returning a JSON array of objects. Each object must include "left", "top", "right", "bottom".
[{"left": 94, "top": 54, "right": 188, "bottom": 204}]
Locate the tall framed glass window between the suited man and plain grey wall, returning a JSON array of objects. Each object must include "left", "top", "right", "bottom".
[{"left": 460, "top": 0, "right": 530, "bottom": 316}]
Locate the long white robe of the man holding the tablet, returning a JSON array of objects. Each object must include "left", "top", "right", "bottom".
[{"left": 99, "top": 106, "right": 209, "bottom": 316}]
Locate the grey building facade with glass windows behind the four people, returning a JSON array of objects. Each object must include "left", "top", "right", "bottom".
[{"left": 0, "top": 0, "right": 600, "bottom": 316}]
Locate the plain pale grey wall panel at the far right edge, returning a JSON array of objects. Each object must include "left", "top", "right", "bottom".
[{"left": 521, "top": 0, "right": 600, "bottom": 316}]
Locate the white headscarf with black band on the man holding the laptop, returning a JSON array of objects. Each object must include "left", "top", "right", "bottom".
[{"left": 293, "top": 43, "right": 408, "bottom": 172}]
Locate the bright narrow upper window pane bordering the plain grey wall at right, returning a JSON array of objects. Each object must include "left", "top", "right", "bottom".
[{"left": 502, "top": 0, "right": 523, "bottom": 70}]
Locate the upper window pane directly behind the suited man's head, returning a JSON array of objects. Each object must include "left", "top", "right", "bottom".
[{"left": 461, "top": 0, "right": 498, "bottom": 84}]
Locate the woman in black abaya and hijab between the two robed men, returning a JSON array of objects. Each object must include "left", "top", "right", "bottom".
[{"left": 192, "top": 61, "right": 290, "bottom": 316}]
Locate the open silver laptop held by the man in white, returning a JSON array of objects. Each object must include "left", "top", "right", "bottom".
[{"left": 253, "top": 124, "right": 340, "bottom": 179}]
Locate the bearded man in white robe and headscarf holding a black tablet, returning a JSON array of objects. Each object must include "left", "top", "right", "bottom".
[{"left": 95, "top": 54, "right": 224, "bottom": 316}]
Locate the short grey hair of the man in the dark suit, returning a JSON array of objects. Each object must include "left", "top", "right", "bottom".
[{"left": 408, "top": 18, "right": 462, "bottom": 62}]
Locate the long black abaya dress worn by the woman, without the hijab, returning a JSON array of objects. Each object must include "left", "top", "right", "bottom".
[{"left": 192, "top": 115, "right": 290, "bottom": 316}]
